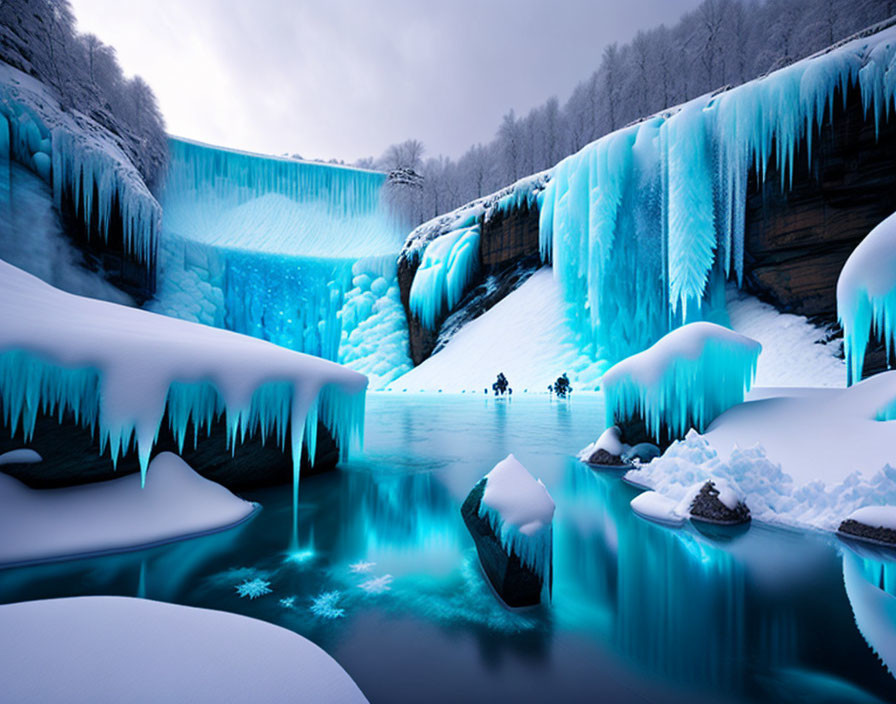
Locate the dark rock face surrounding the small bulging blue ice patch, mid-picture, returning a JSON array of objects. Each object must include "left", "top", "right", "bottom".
[{"left": 398, "top": 205, "right": 541, "bottom": 366}]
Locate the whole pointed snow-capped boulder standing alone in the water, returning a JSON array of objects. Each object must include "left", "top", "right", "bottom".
[{"left": 461, "top": 455, "right": 554, "bottom": 607}]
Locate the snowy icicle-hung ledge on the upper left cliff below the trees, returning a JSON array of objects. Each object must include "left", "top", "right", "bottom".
[{"left": 0, "top": 69, "right": 161, "bottom": 267}]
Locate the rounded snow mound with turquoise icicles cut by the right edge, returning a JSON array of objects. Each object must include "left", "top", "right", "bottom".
[{"left": 837, "top": 210, "right": 896, "bottom": 382}]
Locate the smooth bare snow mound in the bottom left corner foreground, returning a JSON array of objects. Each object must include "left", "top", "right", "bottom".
[{"left": 0, "top": 597, "right": 366, "bottom": 704}]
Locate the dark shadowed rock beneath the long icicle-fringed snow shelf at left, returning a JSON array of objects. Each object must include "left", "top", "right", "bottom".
[{"left": 0, "top": 402, "right": 339, "bottom": 489}]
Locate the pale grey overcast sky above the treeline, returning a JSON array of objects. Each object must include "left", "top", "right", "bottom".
[{"left": 71, "top": 0, "right": 698, "bottom": 161}]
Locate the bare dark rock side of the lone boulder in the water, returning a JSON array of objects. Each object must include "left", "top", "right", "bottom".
[{"left": 460, "top": 479, "right": 544, "bottom": 607}]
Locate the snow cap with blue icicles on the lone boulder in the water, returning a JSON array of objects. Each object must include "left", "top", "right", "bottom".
[{"left": 479, "top": 455, "right": 554, "bottom": 584}]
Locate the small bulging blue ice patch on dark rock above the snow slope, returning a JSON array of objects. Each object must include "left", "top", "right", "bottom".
[{"left": 409, "top": 223, "right": 479, "bottom": 330}]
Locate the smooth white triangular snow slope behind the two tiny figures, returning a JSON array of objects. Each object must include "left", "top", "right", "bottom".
[{"left": 390, "top": 267, "right": 606, "bottom": 393}]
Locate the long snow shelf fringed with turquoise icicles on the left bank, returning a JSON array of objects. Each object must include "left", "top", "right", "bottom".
[{"left": 0, "top": 262, "right": 367, "bottom": 486}]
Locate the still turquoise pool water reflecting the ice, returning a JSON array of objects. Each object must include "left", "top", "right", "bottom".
[{"left": 0, "top": 394, "right": 896, "bottom": 702}]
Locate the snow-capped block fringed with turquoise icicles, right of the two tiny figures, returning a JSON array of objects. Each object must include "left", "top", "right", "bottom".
[{"left": 602, "top": 322, "right": 762, "bottom": 439}]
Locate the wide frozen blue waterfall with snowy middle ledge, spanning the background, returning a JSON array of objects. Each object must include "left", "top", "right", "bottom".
[{"left": 152, "top": 139, "right": 409, "bottom": 381}]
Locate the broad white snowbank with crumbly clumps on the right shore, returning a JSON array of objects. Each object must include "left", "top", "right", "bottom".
[{"left": 626, "top": 372, "right": 896, "bottom": 530}]
